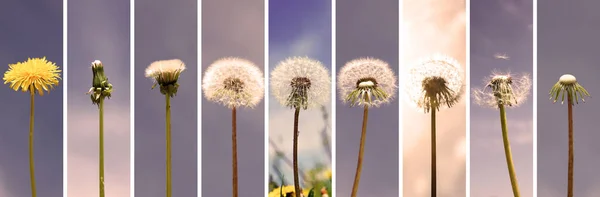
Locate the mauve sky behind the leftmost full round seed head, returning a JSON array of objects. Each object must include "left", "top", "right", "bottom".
[{"left": 201, "top": 0, "right": 265, "bottom": 196}]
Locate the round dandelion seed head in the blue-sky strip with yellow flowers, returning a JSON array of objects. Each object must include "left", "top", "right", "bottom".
[{"left": 270, "top": 57, "right": 331, "bottom": 109}]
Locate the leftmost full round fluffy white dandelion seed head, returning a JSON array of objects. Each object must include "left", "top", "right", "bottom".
[{"left": 202, "top": 57, "right": 264, "bottom": 108}]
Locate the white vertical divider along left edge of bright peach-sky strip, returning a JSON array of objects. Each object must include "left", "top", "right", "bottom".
[{"left": 397, "top": 0, "right": 404, "bottom": 197}]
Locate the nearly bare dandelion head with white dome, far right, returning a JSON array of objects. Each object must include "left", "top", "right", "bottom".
[{"left": 550, "top": 74, "right": 590, "bottom": 104}]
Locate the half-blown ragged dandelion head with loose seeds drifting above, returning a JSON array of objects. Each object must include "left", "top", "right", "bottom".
[{"left": 472, "top": 71, "right": 532, "bottom": 108}]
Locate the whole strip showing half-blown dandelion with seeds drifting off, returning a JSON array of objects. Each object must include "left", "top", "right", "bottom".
[{"left": 469, "top": 0, "right": 533, "bottom": 197}]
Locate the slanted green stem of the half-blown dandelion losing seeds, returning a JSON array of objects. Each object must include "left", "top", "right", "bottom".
[{"left": 498, "top": 104, "right": 521, "bottom": 197}]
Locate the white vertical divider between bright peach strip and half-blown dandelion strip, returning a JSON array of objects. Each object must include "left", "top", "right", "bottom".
[{"left": 465, "top": 0, "right": 471, "bottom": 197}]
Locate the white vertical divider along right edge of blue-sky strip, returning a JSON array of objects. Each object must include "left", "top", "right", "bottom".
[{"left": 329, "top": 0, "right": 337, "bottom": 196}]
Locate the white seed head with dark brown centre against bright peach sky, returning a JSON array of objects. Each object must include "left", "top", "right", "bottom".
[{"left": 404, "top": 54, "right": 464, "bottom": 113}]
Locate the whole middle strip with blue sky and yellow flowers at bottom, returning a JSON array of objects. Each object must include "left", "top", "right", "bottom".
[{"left": 267, "top": 0, "right": 335, "bottom": 197}]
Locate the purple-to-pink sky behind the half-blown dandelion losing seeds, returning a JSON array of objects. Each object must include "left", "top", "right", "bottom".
[{"left": 470, "top": 0, "right": 533, "bottom": 197}]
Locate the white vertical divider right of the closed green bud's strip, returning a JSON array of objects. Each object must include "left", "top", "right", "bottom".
[{"left": 129, "top": 0, "right": 135, "bottom": 197}]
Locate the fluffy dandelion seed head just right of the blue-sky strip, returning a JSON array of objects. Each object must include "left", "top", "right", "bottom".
[{"left": 337, "top": 58, "right": 398, "bottom": 107}]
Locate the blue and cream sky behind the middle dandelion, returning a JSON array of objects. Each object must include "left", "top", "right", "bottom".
[{"left": 268, "top": 0, "right": 331, "bottom": 189}]
